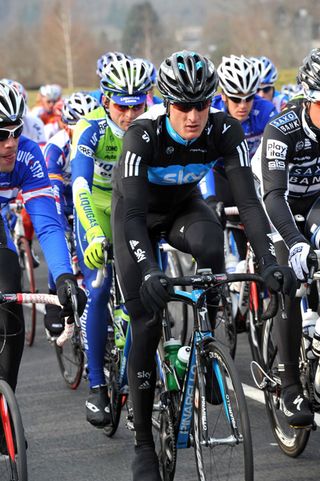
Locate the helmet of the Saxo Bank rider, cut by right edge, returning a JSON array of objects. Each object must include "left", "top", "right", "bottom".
[{"left": 297, "top": 48, "right": 320, "bottom": 102}]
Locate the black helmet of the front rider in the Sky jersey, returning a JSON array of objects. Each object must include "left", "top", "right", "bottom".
[{"left": 157, "top": 50, "right": 219, "bottom": 103}]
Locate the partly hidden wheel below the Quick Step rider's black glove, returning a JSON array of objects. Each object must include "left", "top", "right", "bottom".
[{"left": 54, "top": 326, "right": 84, "bottom": 390}]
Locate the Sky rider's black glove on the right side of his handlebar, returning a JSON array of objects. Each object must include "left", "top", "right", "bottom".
[{"left": 261, "top": 264, "right": 297, "bottom": 299}]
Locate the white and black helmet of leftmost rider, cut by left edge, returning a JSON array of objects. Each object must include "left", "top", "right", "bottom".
[{"left": 0, "top": 81, "right": 25, "bottom": 127}]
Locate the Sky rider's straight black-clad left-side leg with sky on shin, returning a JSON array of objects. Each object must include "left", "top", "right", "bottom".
[{"left": 112, "top": 197, "right": 161, "bottom": 481}]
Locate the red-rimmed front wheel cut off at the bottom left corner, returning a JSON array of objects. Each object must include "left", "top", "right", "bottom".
[{"left": 0, "top": 379, "right": 28, "bottom": 481}]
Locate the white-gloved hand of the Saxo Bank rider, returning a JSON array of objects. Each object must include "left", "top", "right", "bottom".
[{"left": 289, "top": 242, "right": 318, "bottom": 281}]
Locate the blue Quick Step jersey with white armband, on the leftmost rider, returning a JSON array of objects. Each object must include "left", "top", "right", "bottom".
[{"left": 0, "top": 135, "right": 72, "bottom": 280}]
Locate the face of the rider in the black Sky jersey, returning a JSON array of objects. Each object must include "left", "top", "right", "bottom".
[{"left": 169, "top": 102, "right": 210, "bottom": 140}]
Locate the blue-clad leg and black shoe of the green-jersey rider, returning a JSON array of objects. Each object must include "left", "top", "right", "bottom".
[{"left": 75, "top": 212, "right": 112, "bottom": 427}]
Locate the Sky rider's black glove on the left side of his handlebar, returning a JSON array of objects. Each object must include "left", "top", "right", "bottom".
[{"left": 140, "top": 269, "right": 172, "bottom": 314}]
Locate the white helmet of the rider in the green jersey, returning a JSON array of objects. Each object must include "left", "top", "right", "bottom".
[{"left": 100, "top": 58, "right": 152, "bottom": 100}]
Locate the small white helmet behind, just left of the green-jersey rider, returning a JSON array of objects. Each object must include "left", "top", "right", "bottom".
[{"left": 61, "top": 92, "right": 99, "bottom": 125}]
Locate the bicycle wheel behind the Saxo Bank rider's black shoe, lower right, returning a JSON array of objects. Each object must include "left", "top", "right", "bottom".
[{"left": 262, "top": 319, "right": 310, "bottom": 458}]
